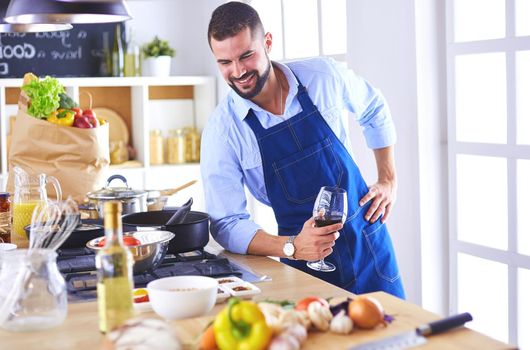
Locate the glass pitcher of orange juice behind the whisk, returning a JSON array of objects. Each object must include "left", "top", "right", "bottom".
[{"left": 11, "top": 167, "right": 62, "bottom": 248}]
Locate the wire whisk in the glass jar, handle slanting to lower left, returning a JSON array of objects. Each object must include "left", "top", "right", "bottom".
[{"left": 0, "top": 197, "right": 79, "bottom": 325}]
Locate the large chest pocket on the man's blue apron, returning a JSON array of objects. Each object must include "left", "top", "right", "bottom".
[{"left": 272, "top": 138, "right": 343, "bottom": 204}]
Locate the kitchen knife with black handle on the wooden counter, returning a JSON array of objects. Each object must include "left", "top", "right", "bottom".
[{"left": 348, "top": 312, "right": 473, "bottom": 350}]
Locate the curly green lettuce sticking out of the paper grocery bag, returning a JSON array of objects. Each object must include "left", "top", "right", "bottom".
[{"left": 22, "top": 76, "right": 64, "bottom": 119}]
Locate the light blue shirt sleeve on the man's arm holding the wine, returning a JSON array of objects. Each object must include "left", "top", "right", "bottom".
[{"left": 201, "top": 121, "right": 260, "bottom": 254}]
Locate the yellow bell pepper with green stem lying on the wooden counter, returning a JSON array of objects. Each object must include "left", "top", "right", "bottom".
[{"left": 213, "top": 298, "right": 272, "bottom": 350}]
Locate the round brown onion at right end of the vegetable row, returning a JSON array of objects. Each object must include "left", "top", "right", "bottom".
[{"left": 348, "top": 296, "right": 385, "bottom": 329}]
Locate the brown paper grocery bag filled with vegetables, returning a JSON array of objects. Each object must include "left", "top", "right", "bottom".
[{"left": 7, "top": 92, "right": 110, "bottom": 203}]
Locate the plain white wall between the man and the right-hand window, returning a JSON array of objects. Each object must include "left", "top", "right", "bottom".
[{"left": 347, "top": 0, "right": 421, "bottom": 304}]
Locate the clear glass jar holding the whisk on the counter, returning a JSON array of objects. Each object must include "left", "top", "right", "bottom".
[{"left": 0, "top": 249, "right": 68, "bottom": 331}]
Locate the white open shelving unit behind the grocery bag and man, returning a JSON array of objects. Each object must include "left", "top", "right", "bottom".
[{"left": 0, "top": 76, "right": 216, "bottom": 210}]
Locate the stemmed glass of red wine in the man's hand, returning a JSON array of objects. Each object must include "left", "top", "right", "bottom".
[{"left": 307, "top": 186, "right": 348, "bottom": 272}]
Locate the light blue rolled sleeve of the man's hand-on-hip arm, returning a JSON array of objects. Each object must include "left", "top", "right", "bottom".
[{"left": 334, "top": 59, "right": 397, "bottom": 149}]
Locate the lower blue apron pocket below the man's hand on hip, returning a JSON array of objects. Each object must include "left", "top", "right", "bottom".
[{"left": 363, "top": 223, "right": 399, "bottom": 282}]
